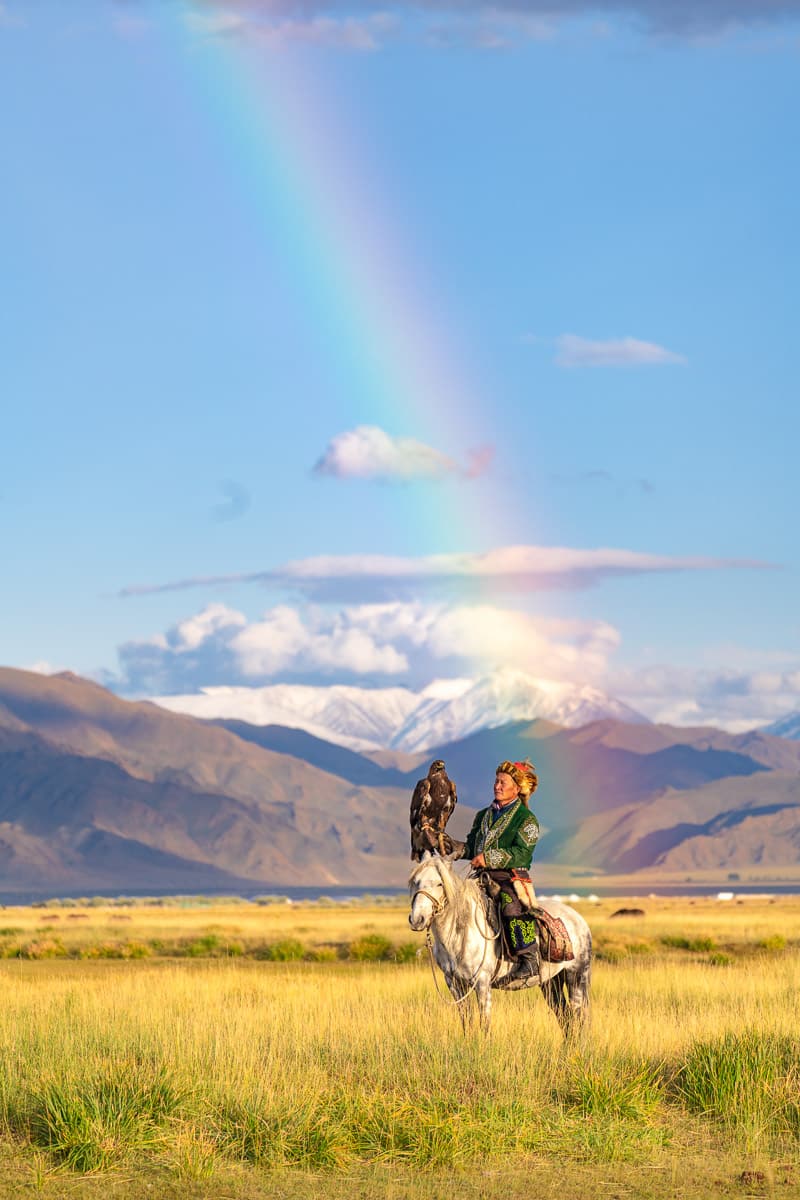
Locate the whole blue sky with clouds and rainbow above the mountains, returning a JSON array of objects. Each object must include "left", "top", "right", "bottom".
[{"left": 0, "top": 0, "right": 800, "bottom": 730}]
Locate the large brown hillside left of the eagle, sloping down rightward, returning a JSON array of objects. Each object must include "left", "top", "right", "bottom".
[{"left": 0, "top": 670, "right": 424, "bottom": 889}]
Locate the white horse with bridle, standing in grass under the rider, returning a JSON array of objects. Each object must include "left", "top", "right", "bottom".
[{"left": 408, "top": 853, "right": 591, "bottom": 1033}]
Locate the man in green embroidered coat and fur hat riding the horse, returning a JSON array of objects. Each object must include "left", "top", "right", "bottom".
[{"left": 461, "top": 761, "right": 539, "bottom": 990}]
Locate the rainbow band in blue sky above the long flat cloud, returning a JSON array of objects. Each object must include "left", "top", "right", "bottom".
[{"left": 160, "top": 6, "right": 513, "bottom": 550}]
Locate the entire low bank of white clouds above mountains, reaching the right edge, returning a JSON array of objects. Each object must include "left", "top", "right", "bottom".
[{"left": 107, "top": 601, "right": 800, "bottom": 732}]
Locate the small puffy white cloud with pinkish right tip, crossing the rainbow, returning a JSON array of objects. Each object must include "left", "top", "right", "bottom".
[{"left": 314, "top": 425, "right": 492, "bottom": 484}]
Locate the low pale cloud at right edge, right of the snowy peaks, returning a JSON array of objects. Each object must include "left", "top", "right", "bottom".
[{"left": 608, "top": 664, "right": 800, "bottom": 733}]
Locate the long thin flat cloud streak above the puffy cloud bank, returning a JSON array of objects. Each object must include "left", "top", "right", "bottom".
[{"left": 120, "top": 546, "right": 771, "bottom": 601}]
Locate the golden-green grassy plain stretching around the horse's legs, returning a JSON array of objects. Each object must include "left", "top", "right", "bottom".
[{"left": 0, "top": 898, "right": 800, "bottom": 1200}]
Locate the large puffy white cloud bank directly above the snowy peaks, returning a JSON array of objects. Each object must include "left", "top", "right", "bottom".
[{"left": 112, "top": 602, "right": 619, "bottom": 695}]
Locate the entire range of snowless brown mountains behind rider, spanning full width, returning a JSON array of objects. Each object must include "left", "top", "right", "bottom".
[{"left": 0, "top": 668, "right": 800, "bottom": 895}]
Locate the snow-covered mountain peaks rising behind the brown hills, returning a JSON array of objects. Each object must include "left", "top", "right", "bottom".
[{"left": 155, "top": 668, "right": 646, "bottom": 752}]
